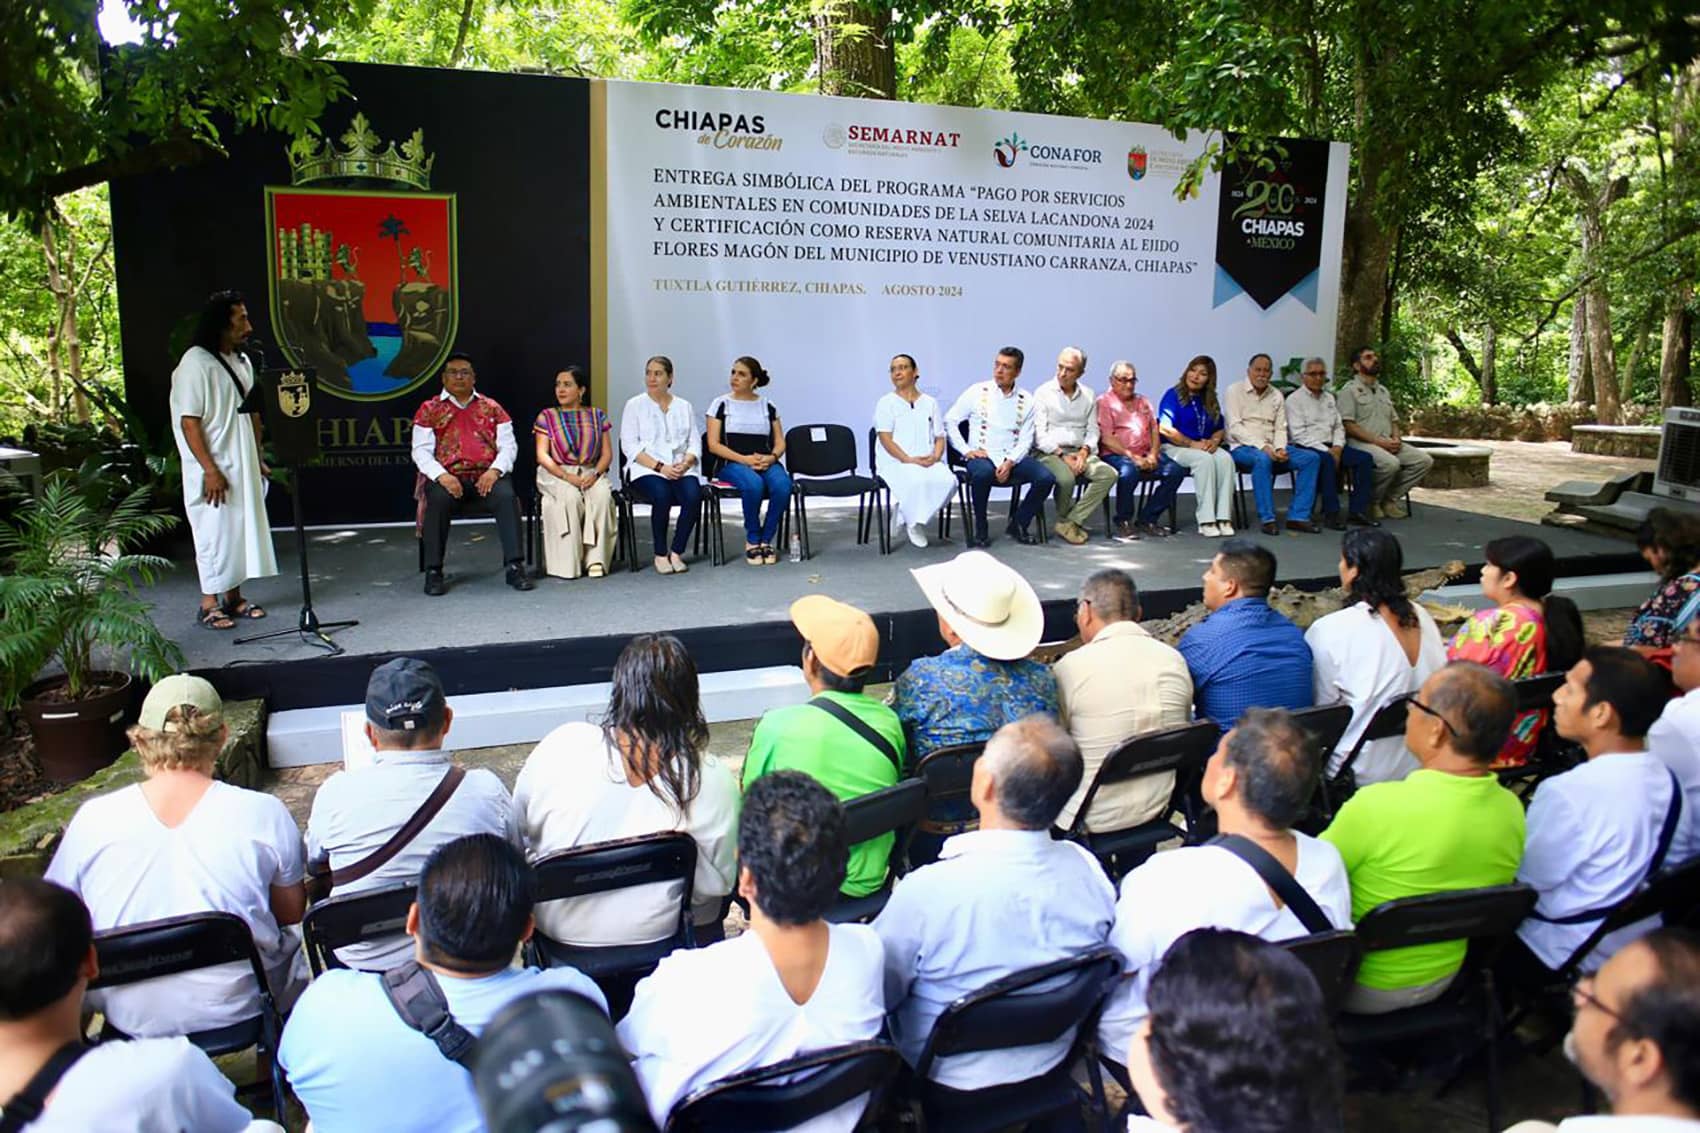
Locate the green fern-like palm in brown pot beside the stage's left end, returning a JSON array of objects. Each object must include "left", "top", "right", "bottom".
[{"left": 0, "top": 473, "right": 184, "bottom": 708}]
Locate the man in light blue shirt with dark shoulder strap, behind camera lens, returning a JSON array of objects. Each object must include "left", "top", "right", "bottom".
[{"left": 279, "top": 834, "right": 607, "bottom": 1133}]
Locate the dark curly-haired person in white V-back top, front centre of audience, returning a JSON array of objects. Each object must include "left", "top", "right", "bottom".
[{"left": 619, "top": 771, "right": 886, "bottom": 1133}]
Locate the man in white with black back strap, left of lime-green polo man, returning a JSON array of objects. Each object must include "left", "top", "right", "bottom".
[{"left": 1098, "top": 708, "right": 1352, "bottom": 1060}]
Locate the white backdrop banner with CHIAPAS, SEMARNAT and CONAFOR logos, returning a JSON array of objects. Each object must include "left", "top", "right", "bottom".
[{"left": 595, "top": 82, "right": 1348, "bottom": 445}]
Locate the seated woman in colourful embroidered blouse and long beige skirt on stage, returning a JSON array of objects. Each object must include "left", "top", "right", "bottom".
[{"left": 532, "top": 366, "right": 614, "bottom": 578}]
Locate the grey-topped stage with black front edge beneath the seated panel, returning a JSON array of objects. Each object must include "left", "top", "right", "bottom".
[{"left": 146, "top": 500, "right": 1644, "bottom": 711}]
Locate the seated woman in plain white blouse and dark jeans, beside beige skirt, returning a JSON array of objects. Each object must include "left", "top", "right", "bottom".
[{"left": 621, "top": 354, "right": 702, "bottom": 575}]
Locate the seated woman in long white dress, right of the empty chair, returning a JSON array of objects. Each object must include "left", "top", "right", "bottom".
[{"left": 874, "top": 354, "right": 955, "bottom": 546}]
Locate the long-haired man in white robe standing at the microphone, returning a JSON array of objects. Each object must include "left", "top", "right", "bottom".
[{"left": 172, "top": 291, "right": 277, "bottom": 629}]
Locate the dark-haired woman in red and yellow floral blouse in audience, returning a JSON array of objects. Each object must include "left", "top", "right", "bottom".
[{"left": 1447, "top": 536, "right": 1584, "bottom": 771}]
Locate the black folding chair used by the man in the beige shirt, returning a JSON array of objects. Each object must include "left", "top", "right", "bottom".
[{"left": 1068, "top": 720, "right": 1222, "bottom": 881}]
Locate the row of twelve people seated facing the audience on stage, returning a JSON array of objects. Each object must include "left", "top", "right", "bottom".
[{"left": 411, "top": 336, "right": 1433, "bottom": 595}]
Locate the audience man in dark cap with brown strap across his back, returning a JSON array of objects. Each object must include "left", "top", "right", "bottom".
[{"left": 308, "top": 657, "right": 520, "bottom": 971}]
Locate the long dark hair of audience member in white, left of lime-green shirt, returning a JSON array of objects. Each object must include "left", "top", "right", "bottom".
[{"left": 602, "top": 633, "right": 709, "bottom": 817}]
